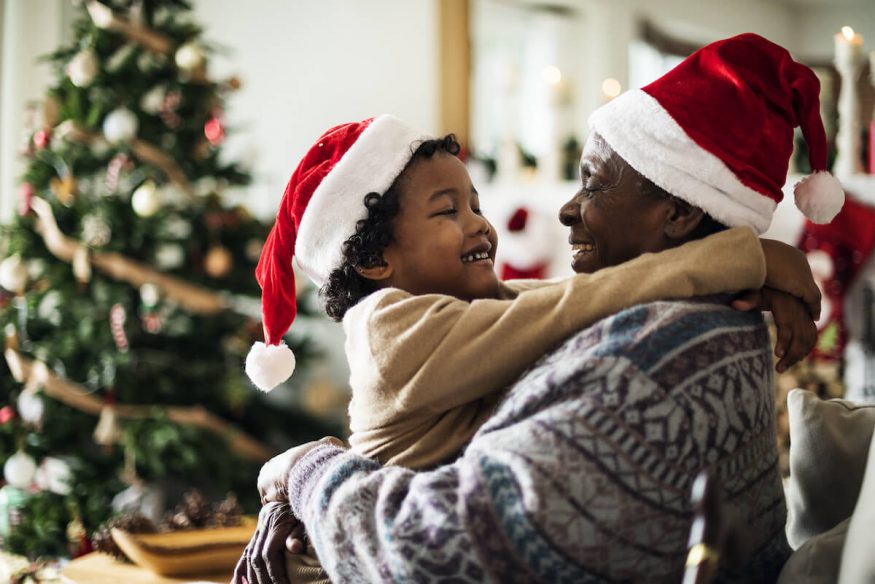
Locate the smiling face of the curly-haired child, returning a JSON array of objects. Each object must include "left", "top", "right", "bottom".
[{"left": 383, "top": 151, "right": 498, "bottom": 300}]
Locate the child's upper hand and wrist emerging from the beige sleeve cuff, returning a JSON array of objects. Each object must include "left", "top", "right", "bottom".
[{"left": 760, "top": 239, "right": 821, "bottom": 320}]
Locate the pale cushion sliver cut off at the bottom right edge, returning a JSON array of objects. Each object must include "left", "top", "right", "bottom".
[{"left": 839, "top": 428, "right": 875, "bottom": 584}]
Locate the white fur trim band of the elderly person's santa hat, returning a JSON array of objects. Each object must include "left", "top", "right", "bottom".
[{"left": 589, "top": 89, "right": 777, "bottom": 233}]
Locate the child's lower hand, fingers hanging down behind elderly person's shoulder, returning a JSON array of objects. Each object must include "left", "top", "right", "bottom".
[{"left": 732, "top": 287, "right": 817, "bottom": 373}]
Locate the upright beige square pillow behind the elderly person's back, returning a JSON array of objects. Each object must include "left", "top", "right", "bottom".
[{"left": 787, "top": 389, "right": 875, "bottom": 549}]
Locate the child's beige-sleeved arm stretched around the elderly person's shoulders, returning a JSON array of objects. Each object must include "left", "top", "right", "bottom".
[{"left": 344, "top": 228, "right": 766, "bottom": 422}]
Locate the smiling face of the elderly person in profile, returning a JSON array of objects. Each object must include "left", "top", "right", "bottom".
[{"left": 559, "top": 134, "right": 676, "bottom": 274}]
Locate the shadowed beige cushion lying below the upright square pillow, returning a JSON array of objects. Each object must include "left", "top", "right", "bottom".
[{"left": 778, "top": 519, "right": 851, "bottom": 584}]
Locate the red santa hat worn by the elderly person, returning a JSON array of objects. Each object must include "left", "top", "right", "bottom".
[{"left": 589, "top": 33, "right": 845, "bottom": 233}]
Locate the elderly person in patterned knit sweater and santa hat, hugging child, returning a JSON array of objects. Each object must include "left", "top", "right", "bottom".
[{"left": 236, "top": 35, "right": 841, "bottom": 582}]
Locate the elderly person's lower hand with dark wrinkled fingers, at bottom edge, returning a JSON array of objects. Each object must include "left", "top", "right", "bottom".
[{"left": 232, "top": 501, "right": 303, "bottom": 584}]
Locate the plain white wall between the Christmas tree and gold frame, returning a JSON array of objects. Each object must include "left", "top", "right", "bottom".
[{"left": 194, "top": 0, "right": 440, "bottom": 217}]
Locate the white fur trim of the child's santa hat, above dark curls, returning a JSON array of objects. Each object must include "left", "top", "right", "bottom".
[{"left": 295, "top": 115, "right": 431, "bottom": 286}]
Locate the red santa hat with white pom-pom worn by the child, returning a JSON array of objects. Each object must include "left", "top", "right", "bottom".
[{"left": 246, "top": 115, "right": 430, "bottom": 391}]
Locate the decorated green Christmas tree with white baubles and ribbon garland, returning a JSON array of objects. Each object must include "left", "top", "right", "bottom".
[{"left": 0, "top": 0, "right": 337, "bottom": 556}]
